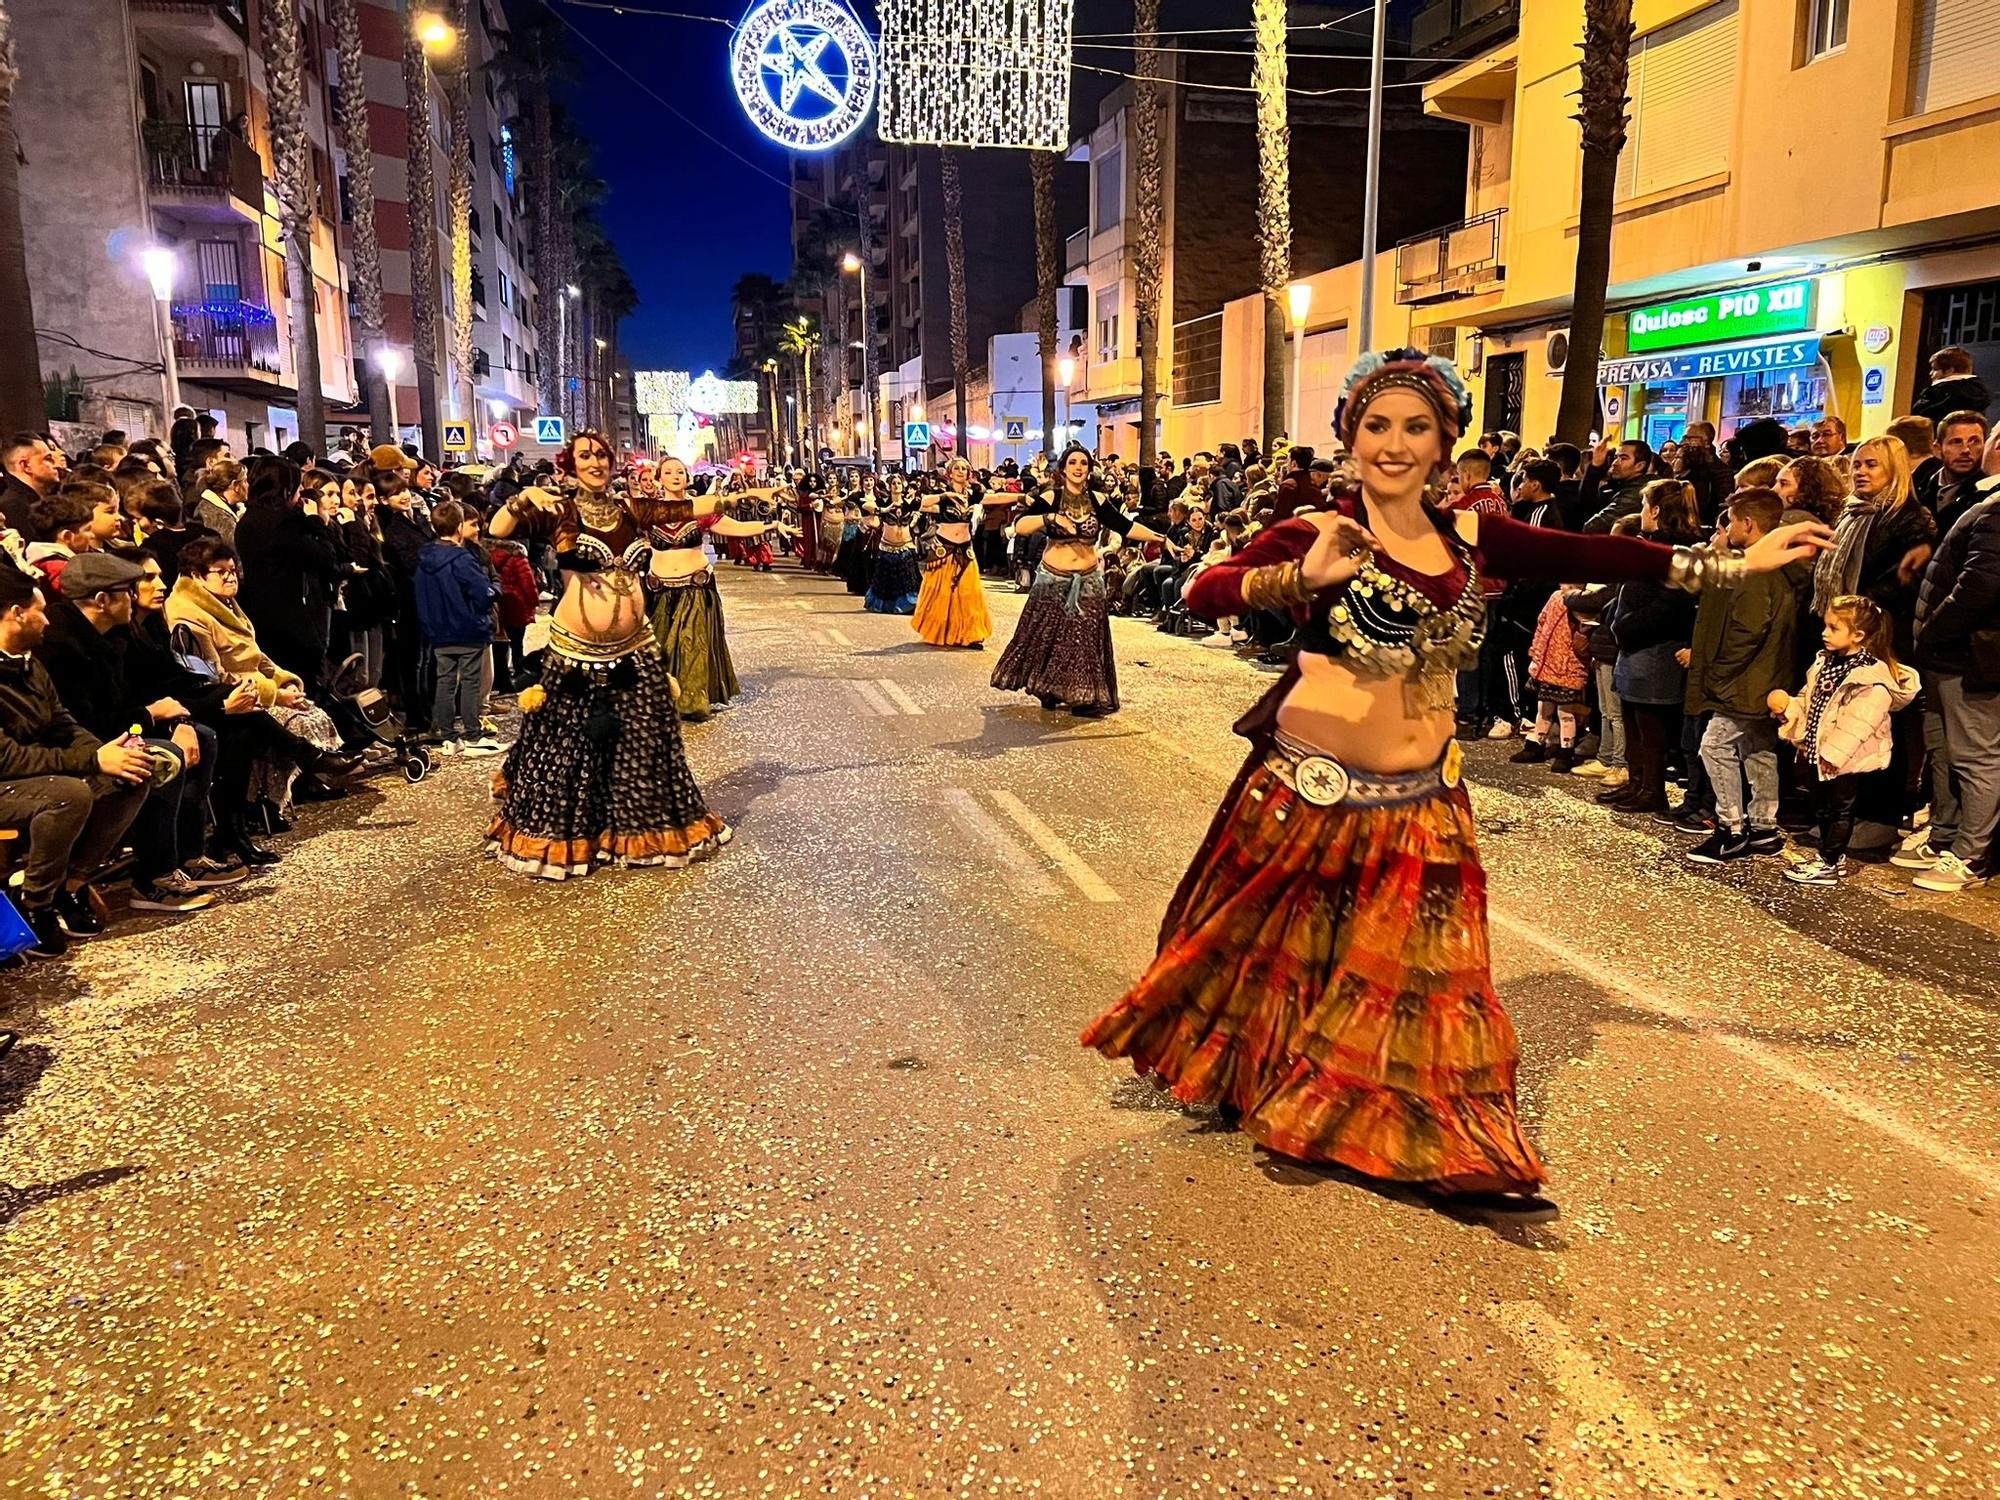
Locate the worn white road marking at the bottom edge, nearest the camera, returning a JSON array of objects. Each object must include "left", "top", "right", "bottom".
[{"left": 1484, "top": 1302, "right": 1728, "bottom": 1500}]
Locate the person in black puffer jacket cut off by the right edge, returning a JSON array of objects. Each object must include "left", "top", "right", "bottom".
[{"left": 1896, "top": 496, "right": 2000, "bottom": 890}]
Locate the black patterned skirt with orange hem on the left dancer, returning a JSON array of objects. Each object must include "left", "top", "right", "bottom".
[{"left": 486, "top": 640, "right": 730, "bottom": 880}]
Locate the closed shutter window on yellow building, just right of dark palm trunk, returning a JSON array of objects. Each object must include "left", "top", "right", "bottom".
[{"left": 1618, "top": 0, "right": 1736, "bottom": 200}]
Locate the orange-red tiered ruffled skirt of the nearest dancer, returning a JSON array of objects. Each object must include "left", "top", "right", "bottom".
[{"left": 1082, "top": 756, "right": 1544, "bottom": 1192}]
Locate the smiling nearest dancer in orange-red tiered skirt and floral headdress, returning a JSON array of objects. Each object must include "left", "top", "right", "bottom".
[{"left": 1084, "top": 350, "right": 1832, "bottom": 1218}]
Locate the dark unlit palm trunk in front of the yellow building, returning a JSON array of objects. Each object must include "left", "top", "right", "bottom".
[{"left": 1556, "top": 0, "right": 1632, "bottom": 448}]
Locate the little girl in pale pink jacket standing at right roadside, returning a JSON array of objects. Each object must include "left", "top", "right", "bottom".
[{"left": 1770, "top": 594, "right": 1918, "bottom": 886}]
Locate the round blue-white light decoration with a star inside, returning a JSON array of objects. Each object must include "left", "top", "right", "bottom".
[{"left": 730, "top": 0, "right": 876, "bottom": 152}]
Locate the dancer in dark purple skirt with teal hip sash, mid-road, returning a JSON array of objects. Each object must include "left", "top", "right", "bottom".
[{"left": 994, "top": 446, "right": 1168, "bottom": 716}]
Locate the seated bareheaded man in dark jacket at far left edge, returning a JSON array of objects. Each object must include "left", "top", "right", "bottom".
[{"left": 0, "top": 566, "right": 152, "bottom": 958}]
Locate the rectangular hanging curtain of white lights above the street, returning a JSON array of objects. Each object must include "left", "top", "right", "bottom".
[{"left": 878, "top": 0, "right": 1074, "bottom": 150}]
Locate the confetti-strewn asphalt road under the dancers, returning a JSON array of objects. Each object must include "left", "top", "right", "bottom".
[{"left": 0, "top": 570, "right": 2000, "bottom": 1500}]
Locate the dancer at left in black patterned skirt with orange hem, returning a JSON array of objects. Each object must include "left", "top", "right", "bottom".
[{"left": 488, "top": 432, "right": 730, "bottom": 880}]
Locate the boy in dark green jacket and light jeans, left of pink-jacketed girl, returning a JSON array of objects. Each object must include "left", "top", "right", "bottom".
[{"left": 1686, "top": 490, "right": 1798, "bottom": 864}]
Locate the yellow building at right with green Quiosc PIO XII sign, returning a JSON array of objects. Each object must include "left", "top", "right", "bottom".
[{"left": 1398, "top": 0, "right": 2000, "bottom": 444}]
